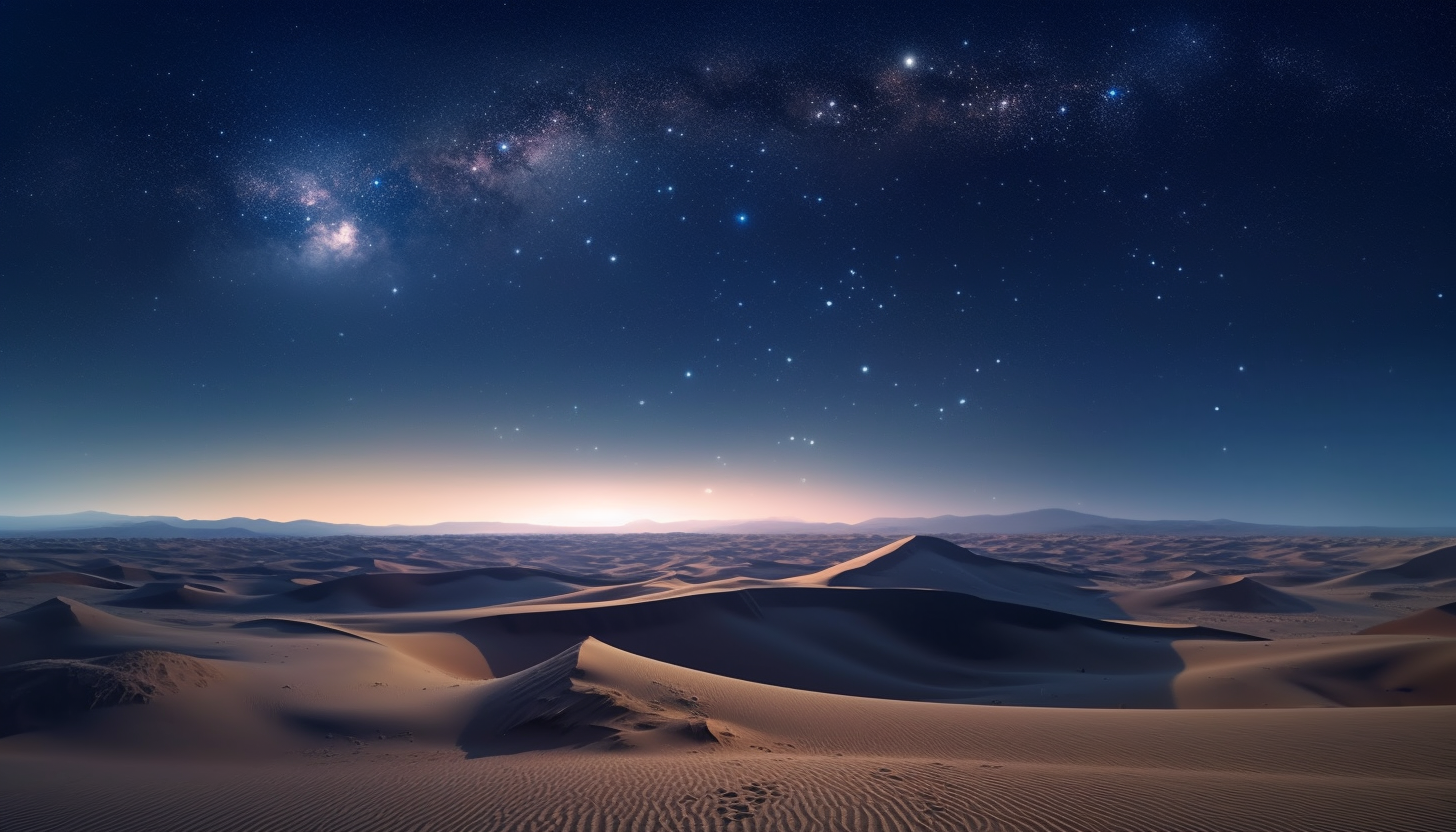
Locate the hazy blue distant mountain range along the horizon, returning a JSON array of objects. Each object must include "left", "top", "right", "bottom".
[{"left": 0, "top": 509, "right": 1456, "bottom": 539}]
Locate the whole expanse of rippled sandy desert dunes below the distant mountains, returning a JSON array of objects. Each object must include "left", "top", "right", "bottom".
[{"left": 0, "top": 535, "right": 1456, "bottom": 832}]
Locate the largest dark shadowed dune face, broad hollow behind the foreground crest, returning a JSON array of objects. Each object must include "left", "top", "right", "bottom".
[{"left": 456, "top": 586, "right": 1251, "bottom": 707}]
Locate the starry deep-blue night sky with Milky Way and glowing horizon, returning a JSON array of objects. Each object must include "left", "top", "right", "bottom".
[{"left": 0, "top": 1, "right": 1456, "bottom": 525}]
